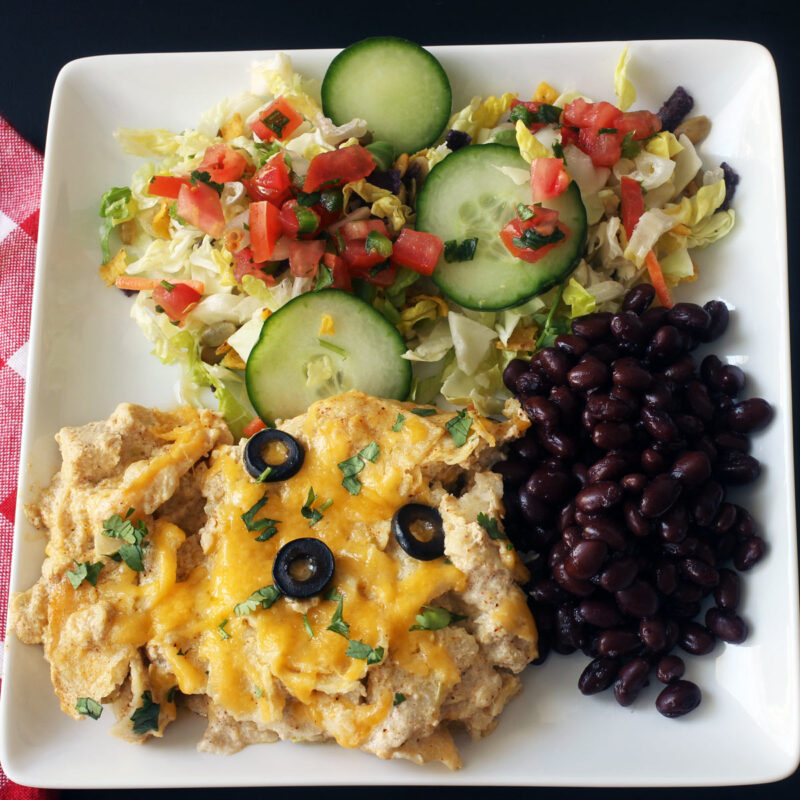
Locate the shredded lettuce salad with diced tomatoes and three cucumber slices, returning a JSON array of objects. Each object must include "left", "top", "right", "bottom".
[{"left": 100, "top": 37, "right": 735, "bottom": 436}]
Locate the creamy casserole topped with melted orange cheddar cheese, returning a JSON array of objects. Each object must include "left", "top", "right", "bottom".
[{"left": 13, "top": 392, "right": 536, "bottom": 768}]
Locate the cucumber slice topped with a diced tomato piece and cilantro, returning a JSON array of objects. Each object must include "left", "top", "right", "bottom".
[{"left": 417, "top": 144, "right": 586, "bottom": 311}]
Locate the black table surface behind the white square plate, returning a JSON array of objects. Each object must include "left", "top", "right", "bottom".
[{"left": 0, "top": 0, "right": 800, "bottom": 800}]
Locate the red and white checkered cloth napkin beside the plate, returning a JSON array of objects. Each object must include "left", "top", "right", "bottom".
[{"left": 0, "top": 117, "right": 58, "bottom": 800}]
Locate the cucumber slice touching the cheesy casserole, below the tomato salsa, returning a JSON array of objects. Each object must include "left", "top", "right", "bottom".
[{"left": 245, "top": 289, "right": 411, "bottom": 422}]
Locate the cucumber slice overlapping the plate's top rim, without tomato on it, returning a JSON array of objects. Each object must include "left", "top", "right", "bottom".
[{"left": 322, "top": 36, "right": 452, "bottom": 153}]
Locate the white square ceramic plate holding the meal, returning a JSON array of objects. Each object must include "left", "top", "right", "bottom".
[{"left": 0, "top": 41, "right": 800, "bottom": 788}]
